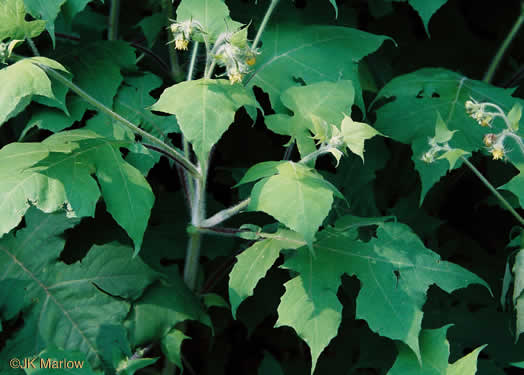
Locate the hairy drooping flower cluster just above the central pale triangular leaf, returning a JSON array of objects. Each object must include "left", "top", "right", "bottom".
[{"left": 212, "top": 29, "right": 259, "bottom": 84}]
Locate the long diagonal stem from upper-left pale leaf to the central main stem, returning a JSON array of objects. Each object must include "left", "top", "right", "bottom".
[{"left": 34, "top": 63, "right": 202, "bottom": 180}]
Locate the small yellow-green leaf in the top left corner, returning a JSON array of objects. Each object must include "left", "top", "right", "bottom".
[{"left": 0, "top": 0, "right": 46, "bottom": 40}]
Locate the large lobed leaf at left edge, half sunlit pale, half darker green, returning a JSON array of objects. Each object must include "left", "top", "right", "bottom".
[{"left": 0, "top": 130, "right": 154, "bottom": 252}]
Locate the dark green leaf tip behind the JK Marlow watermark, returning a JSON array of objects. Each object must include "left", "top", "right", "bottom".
[{"left": 24, "top": 349, "right": 101, "bottom": 375}]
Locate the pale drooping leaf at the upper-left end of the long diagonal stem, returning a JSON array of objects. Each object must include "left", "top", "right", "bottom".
[{"left": 0, "top": 57, "right": 67, "bottom": 125}]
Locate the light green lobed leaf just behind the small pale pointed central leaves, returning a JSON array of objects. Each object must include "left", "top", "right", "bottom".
[{"left": 265, "top": 81, "right": 355, "bottom": 157}]
